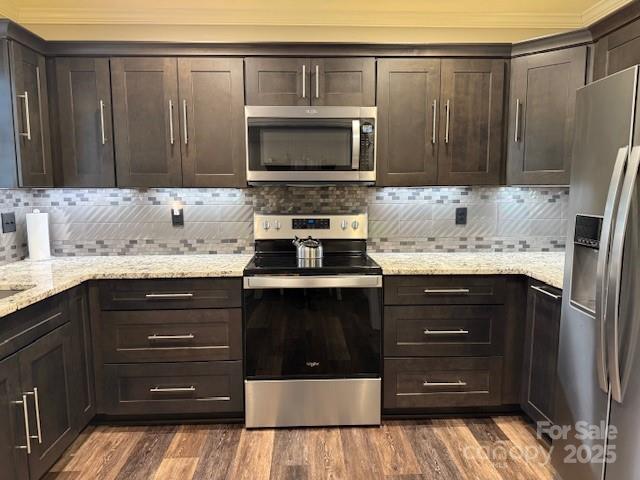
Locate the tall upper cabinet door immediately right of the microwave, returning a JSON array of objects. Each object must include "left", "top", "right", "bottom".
[{"left": 377, "top": 59, "right": 440, "bottom": 186}]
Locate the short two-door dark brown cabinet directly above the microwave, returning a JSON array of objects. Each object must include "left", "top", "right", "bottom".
[{"left": 245, "top": 57, "right": 375, "bottom": 107}]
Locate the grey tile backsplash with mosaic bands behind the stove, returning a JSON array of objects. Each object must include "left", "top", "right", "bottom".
[{"left": 0, "top": 186, "right": 569, "bottom": 264}]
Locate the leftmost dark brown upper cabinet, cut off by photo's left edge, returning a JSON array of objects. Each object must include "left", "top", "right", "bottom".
[{"left": 0, "top": 40, "right": 53, "bottom": 187}]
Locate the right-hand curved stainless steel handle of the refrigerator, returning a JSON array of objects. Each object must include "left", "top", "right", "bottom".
[{"left": 607, "top": 147, "right": 640, "bottom": 403}]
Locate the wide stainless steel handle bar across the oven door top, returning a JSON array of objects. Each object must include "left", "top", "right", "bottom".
[{"left": 244, "top": 275, "right": 382, "bottom": 290}]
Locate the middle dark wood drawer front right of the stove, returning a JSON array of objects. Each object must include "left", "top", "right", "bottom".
[{"left": 384, "top": 305, "right": 504, "bottom": 357}]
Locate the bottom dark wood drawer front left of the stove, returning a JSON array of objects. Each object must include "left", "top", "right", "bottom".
[{"left": 101, "top": 360, "right": 243, "bottom": 415}]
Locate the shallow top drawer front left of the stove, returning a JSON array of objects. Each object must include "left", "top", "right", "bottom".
[{"left": 100, "top": 278, "right": 242, "bottom": 310}]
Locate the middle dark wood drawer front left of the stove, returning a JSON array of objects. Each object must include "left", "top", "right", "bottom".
[{"left": 100, "top": 308, "right": 242, "bottom": 363}]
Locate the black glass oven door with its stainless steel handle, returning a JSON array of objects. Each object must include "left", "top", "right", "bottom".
[{"left": 244, "top": 275, "right": 382, "bottom": 380}]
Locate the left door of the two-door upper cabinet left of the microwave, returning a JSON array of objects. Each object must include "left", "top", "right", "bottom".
[{"left": 111, "top": 58, "right": 182, "bottom": 187}]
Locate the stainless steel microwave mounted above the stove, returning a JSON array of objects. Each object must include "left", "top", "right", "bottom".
[{"left": 245, "top": 106, "right": 376, "bottom": 184}]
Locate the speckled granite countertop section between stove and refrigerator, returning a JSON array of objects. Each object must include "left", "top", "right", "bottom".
[{"left": 370, "top": 252, "right": 564, "bottom": 288}]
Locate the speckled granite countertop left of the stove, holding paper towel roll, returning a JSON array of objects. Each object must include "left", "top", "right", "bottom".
[{"left": 0, "top": 254, "right": 251, "bottom": 317}]
